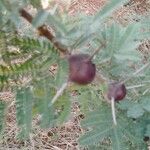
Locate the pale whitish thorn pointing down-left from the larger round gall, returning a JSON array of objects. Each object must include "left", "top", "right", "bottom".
[{"left": 49, "top": 82, "right": 68, "bottom": 106}]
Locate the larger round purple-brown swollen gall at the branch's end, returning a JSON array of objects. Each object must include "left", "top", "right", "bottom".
[{"left": 68, "top": 54, "right": 96, "bottom": 85}]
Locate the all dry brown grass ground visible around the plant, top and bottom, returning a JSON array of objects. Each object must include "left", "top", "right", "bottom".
[{"left": 0, "top": 0, "right": 150, "bottom": 150}]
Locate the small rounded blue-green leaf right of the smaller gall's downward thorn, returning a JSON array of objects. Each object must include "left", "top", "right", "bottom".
[{"left": 127, "top": 103, "right": 144, "bottom": 118}]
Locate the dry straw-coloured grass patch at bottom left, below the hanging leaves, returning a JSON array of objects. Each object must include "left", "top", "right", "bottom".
[{"left": 0, "top": 103, "right": 83, "bottom": 150}]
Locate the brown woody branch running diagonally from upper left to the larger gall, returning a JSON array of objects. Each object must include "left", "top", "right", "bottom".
[{"left": 19, "top": 9, "right": 69, "bottom": 55}]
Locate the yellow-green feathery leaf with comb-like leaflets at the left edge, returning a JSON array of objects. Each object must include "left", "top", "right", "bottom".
[{"left": 0, "top": 36, "right": 59, "bottom": 84}]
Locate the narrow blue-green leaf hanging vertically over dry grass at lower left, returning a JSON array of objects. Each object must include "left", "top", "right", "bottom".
[{"left": 16, "top": 87, "right": 33, "bottom": 139}]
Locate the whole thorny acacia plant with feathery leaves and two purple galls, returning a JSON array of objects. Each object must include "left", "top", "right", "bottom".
[{"left": 0, "top": 0, "right": 150, "bottom": 150}]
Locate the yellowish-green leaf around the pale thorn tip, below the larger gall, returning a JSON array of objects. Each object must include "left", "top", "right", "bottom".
[{"left": 33, "top": 78, "right": 71, "bottom": 128}]
